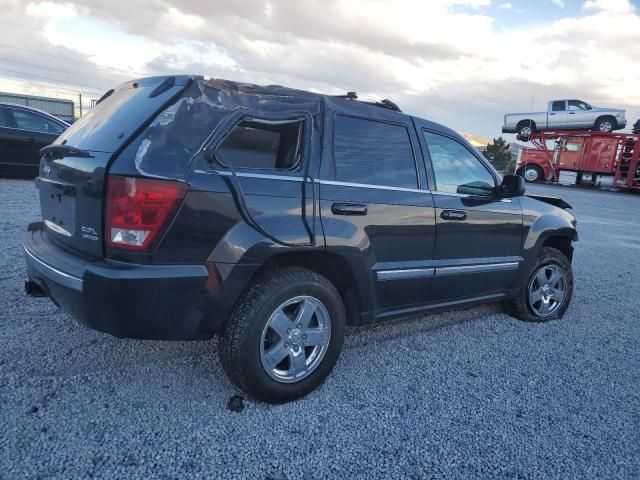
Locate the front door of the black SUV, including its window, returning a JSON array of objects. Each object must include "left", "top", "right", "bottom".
[{"left": 422, "top": 130, "right": 522, "bottom": 299}]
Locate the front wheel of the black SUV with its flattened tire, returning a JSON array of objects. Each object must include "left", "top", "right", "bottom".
[{"left": 504, "top": 247, "right": 573, "bottom": 322}]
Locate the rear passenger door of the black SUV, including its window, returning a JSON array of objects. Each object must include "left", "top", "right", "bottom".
[{"left": 320, "top": 112, "right": 435, "bottom": 316}]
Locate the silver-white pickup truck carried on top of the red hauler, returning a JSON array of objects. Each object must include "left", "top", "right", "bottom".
[{"left": 502, "top": 100, "right": 627, "bottom": 139}]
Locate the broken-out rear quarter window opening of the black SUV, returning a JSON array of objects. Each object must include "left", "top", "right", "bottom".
[{"left": 215, "top": 119, "right": 304, "bottom": 170}]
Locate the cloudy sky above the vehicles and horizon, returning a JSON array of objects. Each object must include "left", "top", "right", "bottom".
[{"left": 0, "top": 0, "right": 640, "bottom": 140}]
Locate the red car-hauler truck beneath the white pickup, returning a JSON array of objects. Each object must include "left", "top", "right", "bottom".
[{"left": 516, "top": 130, "right": 640, "bottom": 190}]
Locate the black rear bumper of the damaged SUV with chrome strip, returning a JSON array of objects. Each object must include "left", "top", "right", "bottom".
[{"left": 24, "top": 223, "right": 244, "bottom": 340}]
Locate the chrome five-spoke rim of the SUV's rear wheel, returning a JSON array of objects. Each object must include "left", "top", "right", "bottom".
[{"left": 260, "top": 295, "right": 331, "bottom": 383}]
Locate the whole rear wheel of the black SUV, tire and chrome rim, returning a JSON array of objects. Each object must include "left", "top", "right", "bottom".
[{"left": 218, "top": 267, "right": 346, "bottom": 403}]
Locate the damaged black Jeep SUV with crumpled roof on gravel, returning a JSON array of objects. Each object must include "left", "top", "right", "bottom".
[{"left": 24, "top": 76, "right": 577, "bottom": 402}]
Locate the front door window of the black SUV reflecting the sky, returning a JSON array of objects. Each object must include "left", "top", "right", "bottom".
[{"left": 424, "top": 131, "right": 495, "bottom": 196}]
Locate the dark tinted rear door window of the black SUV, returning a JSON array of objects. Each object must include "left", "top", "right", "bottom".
[{"left": 334, "top": 115, "right": 418, "bottom": 188}]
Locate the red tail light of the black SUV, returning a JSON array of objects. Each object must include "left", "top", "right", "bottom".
[{"left": 105, "top": 176, "right": 187, "bottom": 252}]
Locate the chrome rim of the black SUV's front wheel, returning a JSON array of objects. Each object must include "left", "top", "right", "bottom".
[{"left": 529, "top": 265, "right": 567, "bottom": 317}]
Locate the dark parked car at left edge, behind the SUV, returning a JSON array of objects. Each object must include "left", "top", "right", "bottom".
[{"left": 0, "top": 103, "right": 69, "bottom": 177}]
